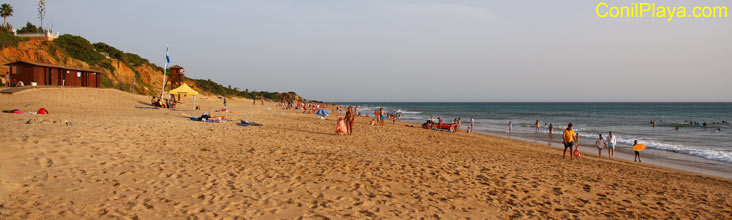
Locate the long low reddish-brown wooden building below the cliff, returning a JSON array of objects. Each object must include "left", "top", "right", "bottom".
[{"left": 5, "top": 61, "right": 102, "bottom": 88}]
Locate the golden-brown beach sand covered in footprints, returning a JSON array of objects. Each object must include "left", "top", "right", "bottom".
[{"left": 0, "top": 88, "right": 732, "bottom": 219}]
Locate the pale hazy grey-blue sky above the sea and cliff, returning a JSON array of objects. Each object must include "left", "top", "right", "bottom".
[{"left": 0, "top": 0, "right": 732, "bottom": 102}]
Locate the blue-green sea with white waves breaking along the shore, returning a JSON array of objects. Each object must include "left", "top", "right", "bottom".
[{"left": 339, "top": 102, "right": 732, "bottom": 167}]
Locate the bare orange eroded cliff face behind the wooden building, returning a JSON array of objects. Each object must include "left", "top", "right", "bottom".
[{"left": 0, "top": 40, "right": 162, "bottom": 94}]
